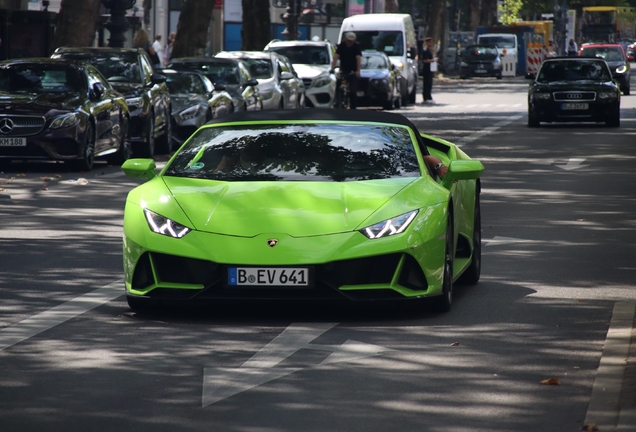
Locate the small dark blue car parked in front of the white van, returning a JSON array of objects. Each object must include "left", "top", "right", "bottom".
[{"left": 358, "top": 51, "right": 402, "bottom": 110}]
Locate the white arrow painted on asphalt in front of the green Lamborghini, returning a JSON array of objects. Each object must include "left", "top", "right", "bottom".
[{"left": 202, "top": 323, "right": 394, "bottom": 407}]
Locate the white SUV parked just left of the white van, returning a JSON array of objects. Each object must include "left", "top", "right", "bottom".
[{"left": 264, "top": 40, "right": 336, "bottom": 108}]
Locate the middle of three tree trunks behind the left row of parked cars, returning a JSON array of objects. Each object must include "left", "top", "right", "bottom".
[{"left": 170, "top": 0, "right": 214, "bottom": 58}]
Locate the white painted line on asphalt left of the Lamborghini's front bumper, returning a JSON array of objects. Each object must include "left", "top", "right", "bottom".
[{"left": 0, "top": 279, "right": 124, "bottom": 351}]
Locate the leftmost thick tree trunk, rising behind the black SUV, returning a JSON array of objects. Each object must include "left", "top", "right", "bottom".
[{"left": 53, "top": 0, "right": 102, "bottom": 53}]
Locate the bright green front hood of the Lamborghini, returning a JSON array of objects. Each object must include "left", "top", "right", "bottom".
[{"left": 163, "top": 177, "right": 417, "bottom": 237}]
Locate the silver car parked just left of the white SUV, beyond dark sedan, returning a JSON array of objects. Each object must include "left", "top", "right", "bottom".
[{"left": 214, "top": 51, "right": 305, "bottom": 110}]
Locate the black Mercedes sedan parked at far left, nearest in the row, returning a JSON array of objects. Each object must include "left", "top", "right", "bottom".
[{"left": 0, "top": 58, "right": 130, "bottom": 171}]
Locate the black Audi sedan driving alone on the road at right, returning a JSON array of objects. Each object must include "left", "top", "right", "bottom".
[{"left": 528, "top": 57, "right": 621, "bottom": 127}]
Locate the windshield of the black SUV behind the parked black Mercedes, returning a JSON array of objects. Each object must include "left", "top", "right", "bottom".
[{"left": 54, "top": 52, "right": 142, "bottom": 83}]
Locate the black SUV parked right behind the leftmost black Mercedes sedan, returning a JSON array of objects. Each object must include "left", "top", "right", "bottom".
[{"left": 51, "top": 47, "right": 172, "bottom": 157}]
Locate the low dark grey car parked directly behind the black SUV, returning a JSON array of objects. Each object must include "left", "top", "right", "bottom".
[{"left": 161, "top": 69, "right": 232, "bottom": 145}]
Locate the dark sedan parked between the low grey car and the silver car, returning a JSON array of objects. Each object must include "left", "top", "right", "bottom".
[{"left": 166, "top": 57, "right": 263, "bottom": 112}]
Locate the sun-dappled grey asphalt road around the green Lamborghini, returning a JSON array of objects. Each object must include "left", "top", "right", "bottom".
[{"left": 0, "top": 79, "right": 636, "bottom": 432}]
